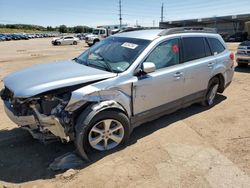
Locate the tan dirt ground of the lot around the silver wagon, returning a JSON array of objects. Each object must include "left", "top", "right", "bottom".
[{"left": 0, "top": 39, "right": 250, "bottom": 188}]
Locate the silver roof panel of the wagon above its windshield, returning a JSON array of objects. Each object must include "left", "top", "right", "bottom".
[{"left": 114, "top": 29, "right": 163, "bottom": 40}]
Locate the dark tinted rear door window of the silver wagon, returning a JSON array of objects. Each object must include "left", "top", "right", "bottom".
[{"left": 182, "top": 37, "right": 206, "bottom": 62}]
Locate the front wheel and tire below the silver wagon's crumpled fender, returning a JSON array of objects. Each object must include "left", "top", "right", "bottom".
[{"left": 75, "top": 110, "right": 130, "bottom": 158}]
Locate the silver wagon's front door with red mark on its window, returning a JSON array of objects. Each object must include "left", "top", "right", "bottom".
[{"left": 133, "top": 38, "right": 185, "bottom": 115}]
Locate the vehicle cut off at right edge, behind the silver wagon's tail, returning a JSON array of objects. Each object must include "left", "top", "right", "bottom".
[{"left": 236, "top": 40, "right": 250, "bottom": 67}]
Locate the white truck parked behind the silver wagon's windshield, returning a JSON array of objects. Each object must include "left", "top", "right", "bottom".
[{"left": 85, "top": 28, "right": 111, "bottom": 46}]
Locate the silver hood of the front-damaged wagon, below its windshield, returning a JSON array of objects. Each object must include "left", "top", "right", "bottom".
[{"left": 3, "top": 61, "right": 117, "bottom": 98}]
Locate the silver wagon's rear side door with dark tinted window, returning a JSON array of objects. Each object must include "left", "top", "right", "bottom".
[{"left": 182, "top": 36, "right": 216, "bottom": 102}]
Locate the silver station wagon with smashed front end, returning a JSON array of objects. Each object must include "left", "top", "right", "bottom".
[{"left": 1, "top": 28, "right": 234, "bottom": 159}]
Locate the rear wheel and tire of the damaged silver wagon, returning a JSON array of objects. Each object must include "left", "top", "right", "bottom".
[{"left": 201, "top": 77, "right": 220, "bottom": 106}]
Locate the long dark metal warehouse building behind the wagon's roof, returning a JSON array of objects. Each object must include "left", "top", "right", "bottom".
[{"left": 160, "top": 14, "right": 250, "bottom": 35}]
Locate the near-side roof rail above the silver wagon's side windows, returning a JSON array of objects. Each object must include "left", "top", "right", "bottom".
[{"left": 159, "top": 27, "right": 217, "bottom": 36}]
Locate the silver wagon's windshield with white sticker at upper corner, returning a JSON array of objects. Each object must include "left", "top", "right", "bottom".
[{"left": 75, "top": 37, "right": 150, "bottom": 73}]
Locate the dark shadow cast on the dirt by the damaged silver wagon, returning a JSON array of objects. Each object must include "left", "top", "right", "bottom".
[{"left": 0, "top": 95, "right": 226, "bottom": 183}]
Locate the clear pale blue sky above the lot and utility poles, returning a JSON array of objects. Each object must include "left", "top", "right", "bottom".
[{"left": 0, "top": 0, "right": 250, "bottom": 27}]
